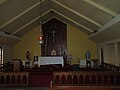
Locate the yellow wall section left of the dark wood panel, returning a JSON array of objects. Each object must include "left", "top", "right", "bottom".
[{"left": 14, "top": 27, "right": 41, "bottom": 60}]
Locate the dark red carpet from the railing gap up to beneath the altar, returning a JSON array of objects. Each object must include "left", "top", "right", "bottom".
[{"left": 27, "top": 65, "right": 71, "bottom": 87}]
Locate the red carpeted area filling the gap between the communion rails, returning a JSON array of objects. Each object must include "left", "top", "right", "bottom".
[{"left": 28, "top": 72, "right": 52, "bottom": 87}]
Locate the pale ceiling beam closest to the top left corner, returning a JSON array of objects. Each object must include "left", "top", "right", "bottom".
[{"left": 0, "top": 0, "right": 45, "bottom": 29}]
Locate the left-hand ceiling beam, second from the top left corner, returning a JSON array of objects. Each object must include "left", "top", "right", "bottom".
[{"left": 11, "top": 10, "right": 51, "bottom": 35}]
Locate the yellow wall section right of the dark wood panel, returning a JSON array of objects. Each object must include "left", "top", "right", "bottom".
[{"left": 67, "top": 25, "right": 97, "bottom": 64}]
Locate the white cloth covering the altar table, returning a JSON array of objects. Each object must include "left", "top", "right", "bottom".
[{"left": 38, "top": 57, "right": 64, "bottom": 67}]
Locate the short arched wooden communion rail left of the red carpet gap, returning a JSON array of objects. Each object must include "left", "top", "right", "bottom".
[{"left": 0, "top": 72, "right": 29, "bottom": 87}]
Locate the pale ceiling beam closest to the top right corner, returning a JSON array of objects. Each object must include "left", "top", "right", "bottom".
[{"left": 83, "top": 0, "right": 119, "bottom": 17}]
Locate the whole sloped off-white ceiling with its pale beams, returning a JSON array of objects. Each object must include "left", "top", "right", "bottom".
[{"left": 0, "top": 0, "right": 120, "bottom": 43}]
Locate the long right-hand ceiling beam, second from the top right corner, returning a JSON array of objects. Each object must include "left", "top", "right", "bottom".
[{"left": 52, "top": 0, "right": 102, "bottom": 27}]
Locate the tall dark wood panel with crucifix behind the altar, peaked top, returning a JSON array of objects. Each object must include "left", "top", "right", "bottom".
[{"left": 41, "top": 18, "right": 67, "bottom": 56}]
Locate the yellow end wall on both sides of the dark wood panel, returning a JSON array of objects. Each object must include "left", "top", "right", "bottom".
[{"left": 14, "top": 25, "right": 96, "bottom": 63}]
